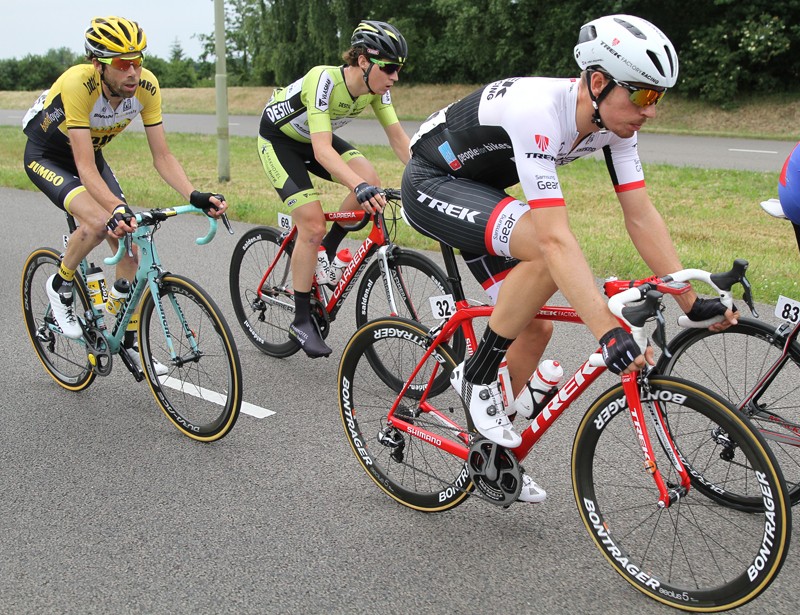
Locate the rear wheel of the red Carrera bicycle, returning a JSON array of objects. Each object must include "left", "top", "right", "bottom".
[{"left": 229, "top": 226, "right": 300, "bottom": 358}]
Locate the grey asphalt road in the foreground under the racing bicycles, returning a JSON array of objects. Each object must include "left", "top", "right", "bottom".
[{"left": 0, "top": 188, "right": 800, "bottom": 615}]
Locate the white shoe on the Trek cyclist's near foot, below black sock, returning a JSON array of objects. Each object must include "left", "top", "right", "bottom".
[{"left": 450, "top": 363, "right": 524, "bottom": 450}]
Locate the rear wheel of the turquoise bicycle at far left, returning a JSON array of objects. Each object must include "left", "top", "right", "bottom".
[{"left": 20, "top": 248, "right": 97, "bottom": 391}]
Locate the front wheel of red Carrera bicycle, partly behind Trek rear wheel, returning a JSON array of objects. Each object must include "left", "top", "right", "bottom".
[{"left": 356, "top": 247, "right": 466, "bottom": 395}]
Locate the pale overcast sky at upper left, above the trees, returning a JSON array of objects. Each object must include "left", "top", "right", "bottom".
[{"left": 0, "top": 0, "right": 214, "bottom": 60}]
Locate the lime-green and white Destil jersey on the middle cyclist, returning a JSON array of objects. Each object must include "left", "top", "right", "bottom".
[{"left": 262, "top": 66, "right": 398, "bottom": 143}]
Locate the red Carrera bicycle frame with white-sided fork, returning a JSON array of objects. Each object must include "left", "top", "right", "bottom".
[{"left": 257, "top": 210, "right": 416, "bottom": 321}]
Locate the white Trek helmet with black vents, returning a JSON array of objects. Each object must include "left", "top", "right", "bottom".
[{"left": 575, "top": 15, "right": 678, "bottom": 88}]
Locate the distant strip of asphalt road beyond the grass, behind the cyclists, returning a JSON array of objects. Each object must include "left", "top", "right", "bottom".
[{"left": 0, "top": 109, "right": 795, "bottom": 172}]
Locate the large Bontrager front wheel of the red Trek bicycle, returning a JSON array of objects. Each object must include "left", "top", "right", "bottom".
[{"left": 572, "top": 376, "right": 791, "bottom": 612}]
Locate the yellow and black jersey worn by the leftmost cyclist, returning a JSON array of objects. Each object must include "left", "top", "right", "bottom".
[{"left": 22, "top": 64, "right": 162, "bottom": 157}]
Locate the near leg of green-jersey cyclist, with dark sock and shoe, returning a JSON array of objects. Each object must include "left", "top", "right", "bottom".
[{"left": 258, "top": 135, "right": 331, "bottom": 358}]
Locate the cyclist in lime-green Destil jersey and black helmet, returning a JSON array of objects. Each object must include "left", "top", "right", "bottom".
[{"left": 258, "top": 21, "right": 410, "bottom": 358}]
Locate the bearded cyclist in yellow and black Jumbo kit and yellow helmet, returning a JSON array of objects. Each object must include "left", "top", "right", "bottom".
[{"left": 22, "top": 17, "right": 228, "bottom": 373}]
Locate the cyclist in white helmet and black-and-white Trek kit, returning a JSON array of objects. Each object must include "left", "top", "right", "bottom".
[{"left": 402, "top": 15, "right": 736, "bottom": 502}]
